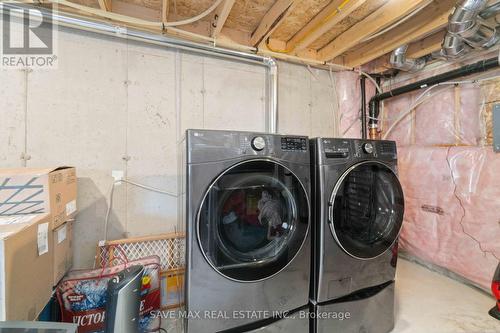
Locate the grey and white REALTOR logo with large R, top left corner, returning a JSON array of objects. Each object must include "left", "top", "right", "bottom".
[{"left": 0, "top": 2, "right": 57, "bottom": 69}]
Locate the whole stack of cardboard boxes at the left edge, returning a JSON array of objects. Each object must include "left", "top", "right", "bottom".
[{"left": 0, "top": 167, "right": 77, "bottom": 321}]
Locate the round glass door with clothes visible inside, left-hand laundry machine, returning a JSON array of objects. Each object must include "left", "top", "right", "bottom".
[{"left": 198, "top": 160, "right": 309, "bottom": 281}]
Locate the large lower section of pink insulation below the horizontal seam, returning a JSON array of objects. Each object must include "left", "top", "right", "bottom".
[{"left": 398, "top": 146, "right": 500, "bottom": 289}]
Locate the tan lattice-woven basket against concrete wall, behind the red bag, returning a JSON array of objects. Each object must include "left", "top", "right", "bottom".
[{"left": 95, "top": 232, "right": 185, "bottom": 310}]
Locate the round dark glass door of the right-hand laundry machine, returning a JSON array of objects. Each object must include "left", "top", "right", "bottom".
[{"left": 329, "top": 161, "right": 404, "bottom": 259}]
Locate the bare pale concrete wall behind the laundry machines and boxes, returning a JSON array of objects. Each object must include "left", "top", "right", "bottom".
[{"left": 0, "top": 23, "right": 359, "bottom": 267}]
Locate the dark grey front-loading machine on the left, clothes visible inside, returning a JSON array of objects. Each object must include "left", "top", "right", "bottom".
[{"left": 180, "top": 130, "right": 311, "bottom": 333}]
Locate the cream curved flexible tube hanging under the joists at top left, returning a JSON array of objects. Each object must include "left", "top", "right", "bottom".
[{"left": 49, "top": 0, "right": 224, "bottom": 29}]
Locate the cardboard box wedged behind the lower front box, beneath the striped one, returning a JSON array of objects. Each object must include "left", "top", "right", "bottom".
[{"left": 52, "top": 220, "right": 74, "bottom": 286}]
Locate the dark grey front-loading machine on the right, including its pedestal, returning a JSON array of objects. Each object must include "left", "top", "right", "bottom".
[{"left": 311, "top": 138, "right": 404, "bottom": 333}]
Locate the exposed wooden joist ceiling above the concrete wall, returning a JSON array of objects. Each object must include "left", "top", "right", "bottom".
[{"left": 44, "top": 0, "right": 464, "bottom": 70}]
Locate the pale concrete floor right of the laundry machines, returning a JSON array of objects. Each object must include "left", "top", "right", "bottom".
[{"left": 393, "top": 259, "right": 500, "bottom": 333}]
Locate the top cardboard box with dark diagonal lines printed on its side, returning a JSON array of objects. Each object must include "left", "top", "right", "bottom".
[{"left": 0, "top": 167, "right": 77, "bottom": 230}]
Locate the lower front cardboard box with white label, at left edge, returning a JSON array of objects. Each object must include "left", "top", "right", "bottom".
[{"left": 0, "top": 214, "right": 54, "bottom": 321}]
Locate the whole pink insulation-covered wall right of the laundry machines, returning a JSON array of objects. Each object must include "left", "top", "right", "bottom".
[{"left": 381, "top": 66, "right": 500, "bottom": 290}]
